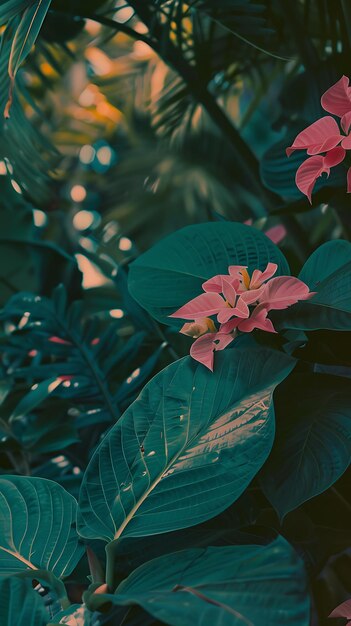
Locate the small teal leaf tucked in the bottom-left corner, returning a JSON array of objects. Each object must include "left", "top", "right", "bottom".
[{"left": 0, "top": 577, "right": 49, "bottom": 626}]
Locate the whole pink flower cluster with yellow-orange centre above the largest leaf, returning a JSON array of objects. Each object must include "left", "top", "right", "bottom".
[{"left": 170, "top": 263, "right": 314, "bottom": 371}]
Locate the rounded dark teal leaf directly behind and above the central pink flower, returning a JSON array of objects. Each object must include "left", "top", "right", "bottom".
[{"left": 129, "top": 222, "right": 290, "bottom": 325}]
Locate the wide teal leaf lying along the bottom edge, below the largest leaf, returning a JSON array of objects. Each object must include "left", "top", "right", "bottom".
[{"left": 88, "top": 537, "right": 309, "bottom": 626}]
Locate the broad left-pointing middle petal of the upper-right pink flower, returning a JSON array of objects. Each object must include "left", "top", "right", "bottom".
[{"left": 286, "top": 115, "right": 342, "bottom": 156}]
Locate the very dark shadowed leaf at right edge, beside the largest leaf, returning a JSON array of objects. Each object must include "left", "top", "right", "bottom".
[{"left": 261, "top": 374, "right": 351, "bottom": 517}]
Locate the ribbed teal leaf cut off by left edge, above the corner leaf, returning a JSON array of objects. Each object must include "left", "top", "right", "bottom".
[{"left": 0, "top": 476, "right": 83, "bottom": 577}]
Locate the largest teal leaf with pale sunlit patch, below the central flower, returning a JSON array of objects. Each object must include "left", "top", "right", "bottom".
[{"left": 78, "top": 349, "right": 294, "bottom": 541}]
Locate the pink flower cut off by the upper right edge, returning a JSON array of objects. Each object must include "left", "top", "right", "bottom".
[{"left": 286, "top": 76, "right": 351, "bottom": 203}]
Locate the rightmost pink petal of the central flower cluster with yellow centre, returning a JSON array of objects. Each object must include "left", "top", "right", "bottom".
[{"left": 259, "top": 276, "right": 314, "bottom": 311}]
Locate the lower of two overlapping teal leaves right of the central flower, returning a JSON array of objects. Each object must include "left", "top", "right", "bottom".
[{"left": 271, "top": 259, "right": 351, "bottom": 330}]
